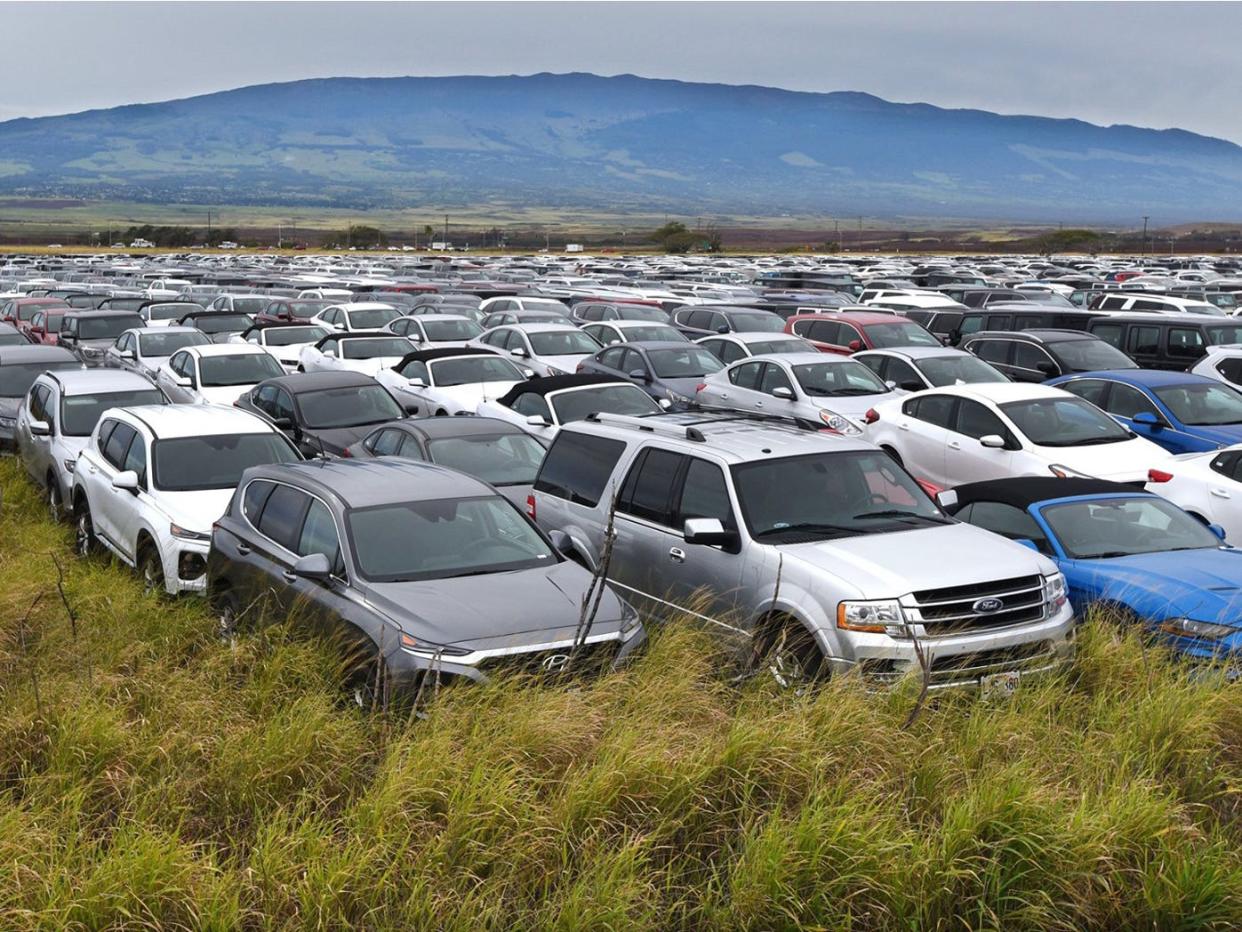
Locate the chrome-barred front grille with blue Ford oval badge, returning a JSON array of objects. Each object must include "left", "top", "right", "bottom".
[{"left": 903, "top": 575, "right": 1046, "bottom": 636}]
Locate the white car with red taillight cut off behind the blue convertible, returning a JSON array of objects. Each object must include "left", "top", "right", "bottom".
[{"left": 1148, "top": 444, "right": 1242, "bottom": 546}]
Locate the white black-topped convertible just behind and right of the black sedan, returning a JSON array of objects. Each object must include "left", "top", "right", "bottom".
[{"left": 375, "top": 347, "right": 530, "bottom": 415}]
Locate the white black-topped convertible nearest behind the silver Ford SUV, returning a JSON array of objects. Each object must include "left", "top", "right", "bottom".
[{"left": 474, "top": 374, "right": 664, "bottom": 440}]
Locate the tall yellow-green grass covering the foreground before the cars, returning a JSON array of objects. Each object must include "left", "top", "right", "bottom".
[{"left": 0, "top": 452, "right": 1242, "bottom": 930}]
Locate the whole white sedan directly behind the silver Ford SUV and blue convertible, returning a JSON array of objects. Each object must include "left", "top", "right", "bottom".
[{"left": 864, "top": 381, "right": 1169, "bottom": 488}]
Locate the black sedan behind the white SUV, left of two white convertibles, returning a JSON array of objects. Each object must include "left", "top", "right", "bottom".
[{"left": 235, "top": 372, "right": 405, "bottom": 456}]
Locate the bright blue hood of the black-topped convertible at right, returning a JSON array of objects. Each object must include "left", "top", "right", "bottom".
[{"left": 1067, "top": 548, "right": 1242, "bottom": 625}]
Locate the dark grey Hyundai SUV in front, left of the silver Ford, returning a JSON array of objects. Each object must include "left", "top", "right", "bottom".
[{"left": 207, "top": 459, "right": 646, "bottom": 707}]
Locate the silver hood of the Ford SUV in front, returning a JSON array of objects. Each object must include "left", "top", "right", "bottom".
[{"left": 779, "top": 524, "right": 1056, "bottom": 599}]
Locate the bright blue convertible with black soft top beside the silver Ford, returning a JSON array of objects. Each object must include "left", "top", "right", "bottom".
[{"left": 939, "top": 477, "right": 1242, "bottom": 661}]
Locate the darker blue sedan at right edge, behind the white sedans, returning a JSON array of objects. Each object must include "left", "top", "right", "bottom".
[{"left": 1045, "top": 369, "right": 1242, "bottom": 454}]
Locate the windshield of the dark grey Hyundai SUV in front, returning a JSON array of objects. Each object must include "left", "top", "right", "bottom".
[{"left": 345, "top": 496, "right": 558, "bottom": 583}]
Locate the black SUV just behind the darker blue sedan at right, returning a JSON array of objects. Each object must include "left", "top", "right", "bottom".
[{"left": 961, "top": 331, "right": 1139, "bottom": 381}]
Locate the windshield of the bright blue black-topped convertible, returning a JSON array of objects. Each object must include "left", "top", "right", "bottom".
[{"left": 1041, "top": 498, "right": 1221, "bottom": 559}]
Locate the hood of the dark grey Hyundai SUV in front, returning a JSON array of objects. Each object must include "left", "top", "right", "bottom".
[{"left": 368, "top": 560, "right": 621, "bottom": 650}]
